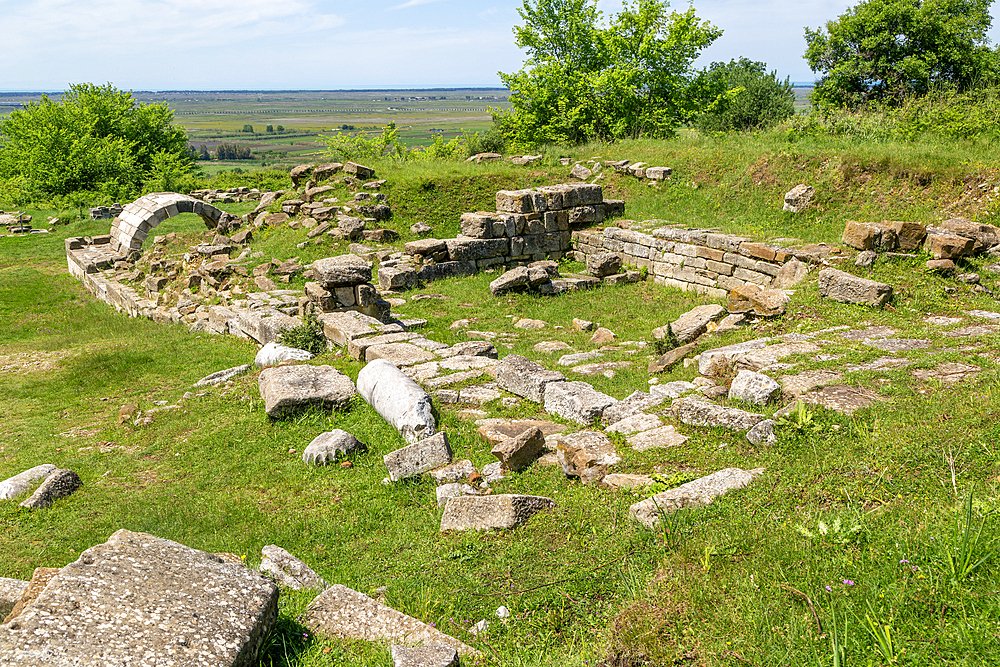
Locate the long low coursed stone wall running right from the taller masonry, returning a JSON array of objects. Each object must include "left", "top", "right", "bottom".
[{"left": 573, "top": 221, "right": 822, "bottom": 298}]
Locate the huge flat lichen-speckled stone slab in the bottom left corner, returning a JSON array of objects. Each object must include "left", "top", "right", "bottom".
[{"left": 0, "top": 530, "right": 278, "bottom": 667}]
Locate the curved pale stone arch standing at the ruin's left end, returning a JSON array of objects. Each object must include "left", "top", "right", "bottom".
[{"left": 111, "top": 192, "right": 228, "bottom": 255}]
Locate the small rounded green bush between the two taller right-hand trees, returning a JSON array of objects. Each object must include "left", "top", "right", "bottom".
[{"left": 696, "top": 58, "right": 795, "bottom": 132}]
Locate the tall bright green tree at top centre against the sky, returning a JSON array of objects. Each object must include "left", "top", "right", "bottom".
[{"left": 494, "top": 0, "right": 722, "bottom": 147}]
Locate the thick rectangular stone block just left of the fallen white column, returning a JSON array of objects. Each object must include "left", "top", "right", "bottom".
[{"left": 257, "top": 366, "right": 358, "bottom": 419}]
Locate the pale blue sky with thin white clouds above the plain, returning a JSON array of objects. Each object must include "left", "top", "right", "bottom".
[{"left": 0, "top": 0, "right": 1000, "bottom": 90}]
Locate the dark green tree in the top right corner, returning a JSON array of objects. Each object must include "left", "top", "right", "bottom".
[{"left": 805, "top": 0, "right": 998, "bottom": 108}]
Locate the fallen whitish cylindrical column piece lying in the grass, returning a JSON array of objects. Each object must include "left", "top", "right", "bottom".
[{"left": 358, "top": 359, "right": 437, "bottom": 444}]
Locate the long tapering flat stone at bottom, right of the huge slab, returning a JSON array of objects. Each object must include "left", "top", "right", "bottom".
[{"left": 302, "top": 584, "right": 480, "bottom": 657}]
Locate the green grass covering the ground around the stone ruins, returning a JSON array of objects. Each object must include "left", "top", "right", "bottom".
[{"left": 0, "top": 129, "right": 1000, "bottom": 667}]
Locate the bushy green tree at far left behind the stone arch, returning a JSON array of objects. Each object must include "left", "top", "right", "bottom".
[{"left": 0, "top": 83, "right": 192, "bottom": 200}]
